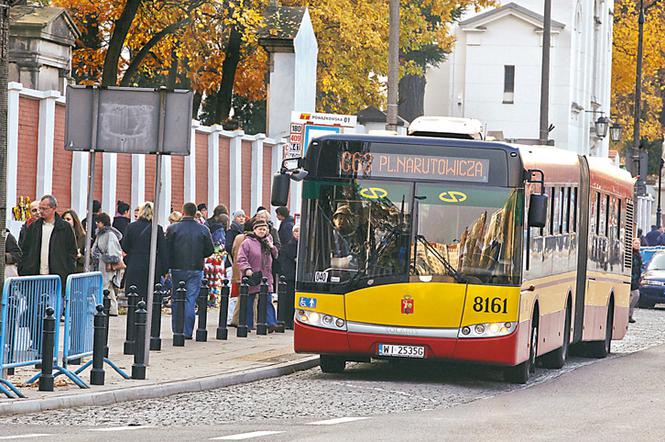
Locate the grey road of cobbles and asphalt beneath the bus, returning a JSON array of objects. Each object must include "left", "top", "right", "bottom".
[{"left": 0, "top": 310, "right": 665, "bottom": 441}]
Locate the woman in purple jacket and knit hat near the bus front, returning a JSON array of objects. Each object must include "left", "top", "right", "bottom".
[{"left": 236, "top": 219, "right": 278, "bottom": 331}]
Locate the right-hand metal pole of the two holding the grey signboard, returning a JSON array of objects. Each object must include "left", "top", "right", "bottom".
[{"left": 143, "top": 87, "right": 166, "bottom": 366}]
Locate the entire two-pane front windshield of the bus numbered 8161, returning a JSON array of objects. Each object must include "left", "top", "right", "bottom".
[{"left": 297, "top": 179, "right": 522, "bottom": 293}]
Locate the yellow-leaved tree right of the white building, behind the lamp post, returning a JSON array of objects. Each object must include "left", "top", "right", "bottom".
[{"left": 612, "top": 0, "right": 665, "bottom": 140}]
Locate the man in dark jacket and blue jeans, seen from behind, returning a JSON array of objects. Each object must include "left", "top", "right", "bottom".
[{"left": 166, "top": 203, "right": 215, "bottom": 339}]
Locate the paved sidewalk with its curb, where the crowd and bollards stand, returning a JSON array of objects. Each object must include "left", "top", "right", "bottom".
[{"left": 0, "top": 310, "right": 318, "bottom": 416}]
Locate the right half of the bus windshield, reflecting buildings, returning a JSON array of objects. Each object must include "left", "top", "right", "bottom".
[{"left": 411, "top": 183, "right": 523, "bottom": 285}]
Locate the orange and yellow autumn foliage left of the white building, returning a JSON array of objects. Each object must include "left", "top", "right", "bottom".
[{"left": 52, "top": 0, "right": 495, "bottom": 122}]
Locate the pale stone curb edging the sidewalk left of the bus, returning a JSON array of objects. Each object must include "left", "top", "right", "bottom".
[{"left": 0, "top": 356, "right": 319, "bottom": 416}]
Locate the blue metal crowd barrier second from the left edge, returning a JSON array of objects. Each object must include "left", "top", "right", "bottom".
[{"left": 62, "top": 272, "right": 104, "bottom": 367}]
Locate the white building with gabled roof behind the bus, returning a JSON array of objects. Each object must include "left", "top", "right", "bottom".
[{"left": 425, "top": 0, "right": 614, "bottom": 156}]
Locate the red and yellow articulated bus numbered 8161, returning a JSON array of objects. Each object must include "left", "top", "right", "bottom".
[{"left": 272, "top": 135, "right": 633, "bottom": 383}]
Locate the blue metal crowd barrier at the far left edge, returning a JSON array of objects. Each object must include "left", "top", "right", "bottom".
[{"left": 0, "top": 276, "right": 62, "bottom": 397}]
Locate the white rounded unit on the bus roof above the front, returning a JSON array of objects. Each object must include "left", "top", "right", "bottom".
[{"left": 407, "top": 117, "right": 485, "bottom": 140}]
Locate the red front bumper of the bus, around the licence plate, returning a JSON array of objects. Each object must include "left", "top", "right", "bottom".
[{"left": 293, "top": 321, "right": 529, "bottom": 366}]
